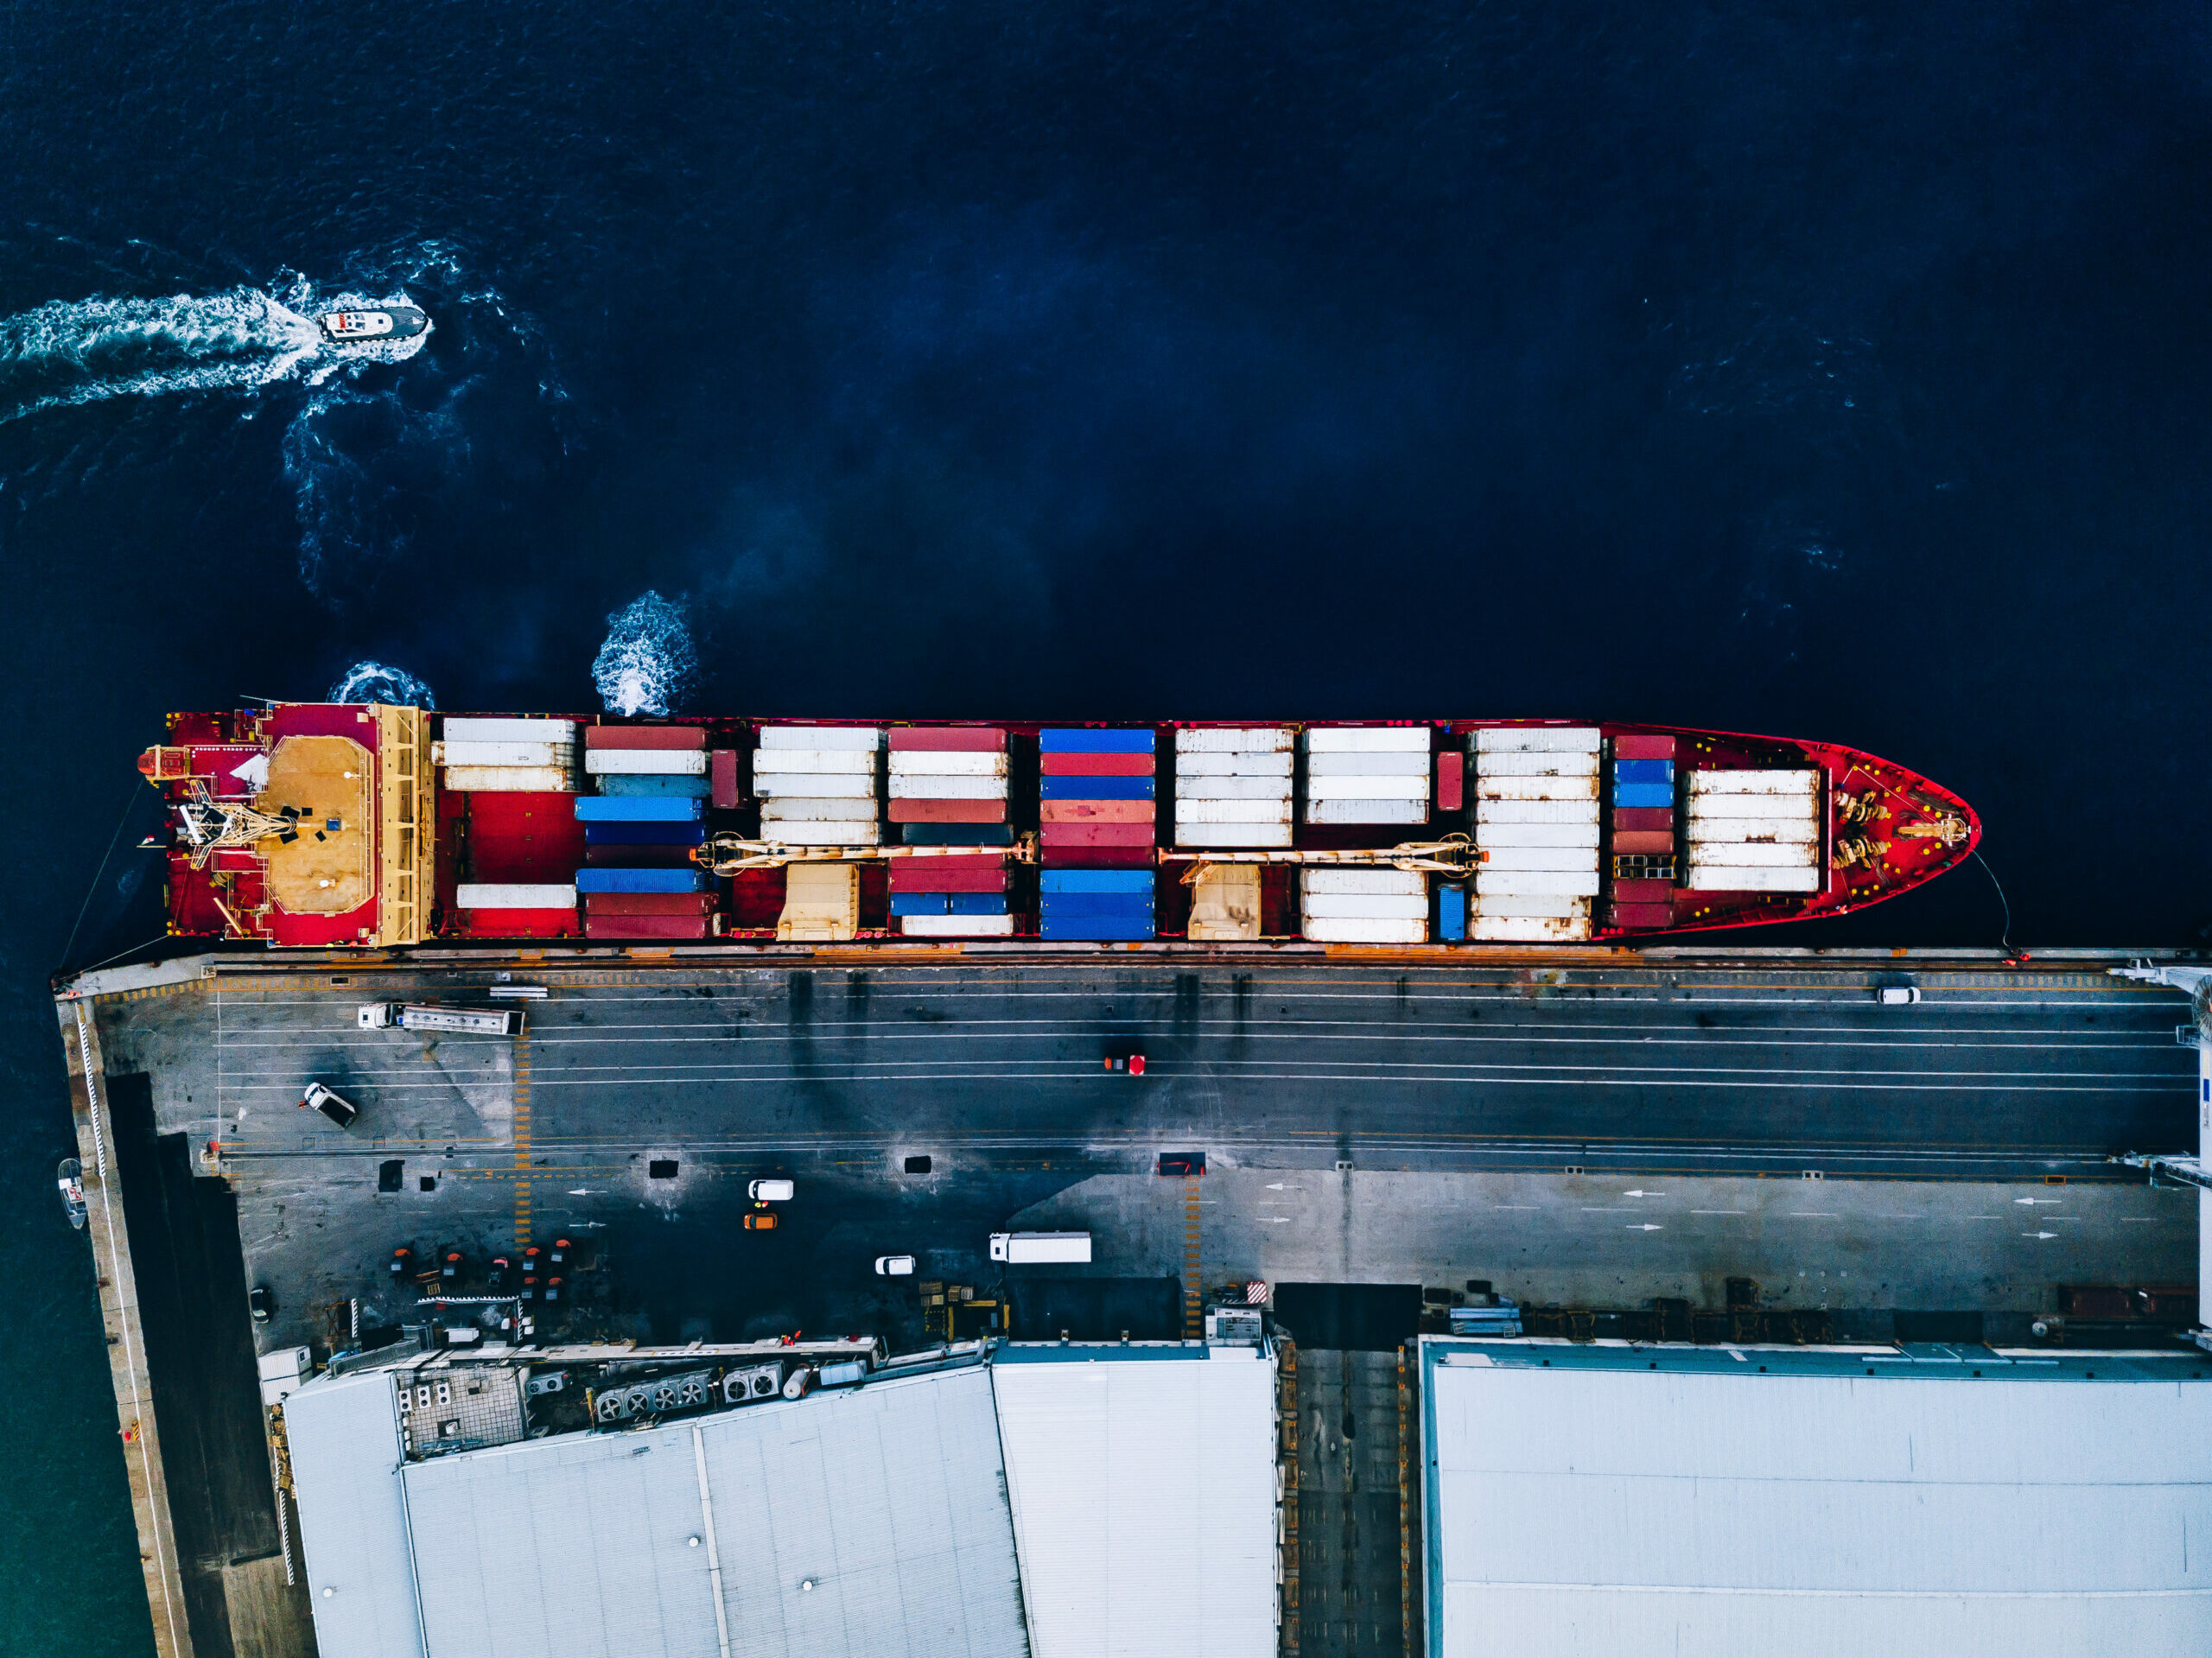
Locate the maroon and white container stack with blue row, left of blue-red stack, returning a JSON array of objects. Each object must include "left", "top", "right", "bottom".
[{"left": 889, "top": 725, "right": 1013, "bottom": 937}]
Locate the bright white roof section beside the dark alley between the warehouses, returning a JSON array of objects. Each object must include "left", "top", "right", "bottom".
[{"left": 991, "top": 1346, "right": 1276, "bottom": 1658}]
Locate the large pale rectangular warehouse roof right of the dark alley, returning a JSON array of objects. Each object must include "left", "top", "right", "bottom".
[{"left": 1422, "top": 1344, "right": 2212, "bottom": 1658}]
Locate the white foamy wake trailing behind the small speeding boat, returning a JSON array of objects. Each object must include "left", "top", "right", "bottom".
[{"left": 0, "top": 283, "right": 431, "bottom": 422}]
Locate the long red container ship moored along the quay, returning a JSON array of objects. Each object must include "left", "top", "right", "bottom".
[{"left": 139, "top": 703, "right": 1980, "bottom": 949}]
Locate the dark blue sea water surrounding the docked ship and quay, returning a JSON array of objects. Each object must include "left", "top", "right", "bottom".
[{"left": 0, "top": 0, "right": 2212, "bottom": 1654}]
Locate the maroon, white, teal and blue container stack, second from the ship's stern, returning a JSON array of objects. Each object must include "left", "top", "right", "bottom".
[{"left": 575, "top": 725, "right": 715, "bottom": 939}]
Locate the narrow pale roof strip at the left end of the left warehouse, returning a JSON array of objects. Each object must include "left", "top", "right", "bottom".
[{"left": 283, "top": 1370, "right": 423, "bottom": 1658}]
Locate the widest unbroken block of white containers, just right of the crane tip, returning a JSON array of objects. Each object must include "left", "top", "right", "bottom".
[{"left": 1466, "top": 725, "right": 1601, "bottom": 944}]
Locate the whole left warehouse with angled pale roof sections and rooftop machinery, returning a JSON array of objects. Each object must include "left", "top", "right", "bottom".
[{"left": 283, "top": 1342, "right": 1279, "bottom": 1658}]
